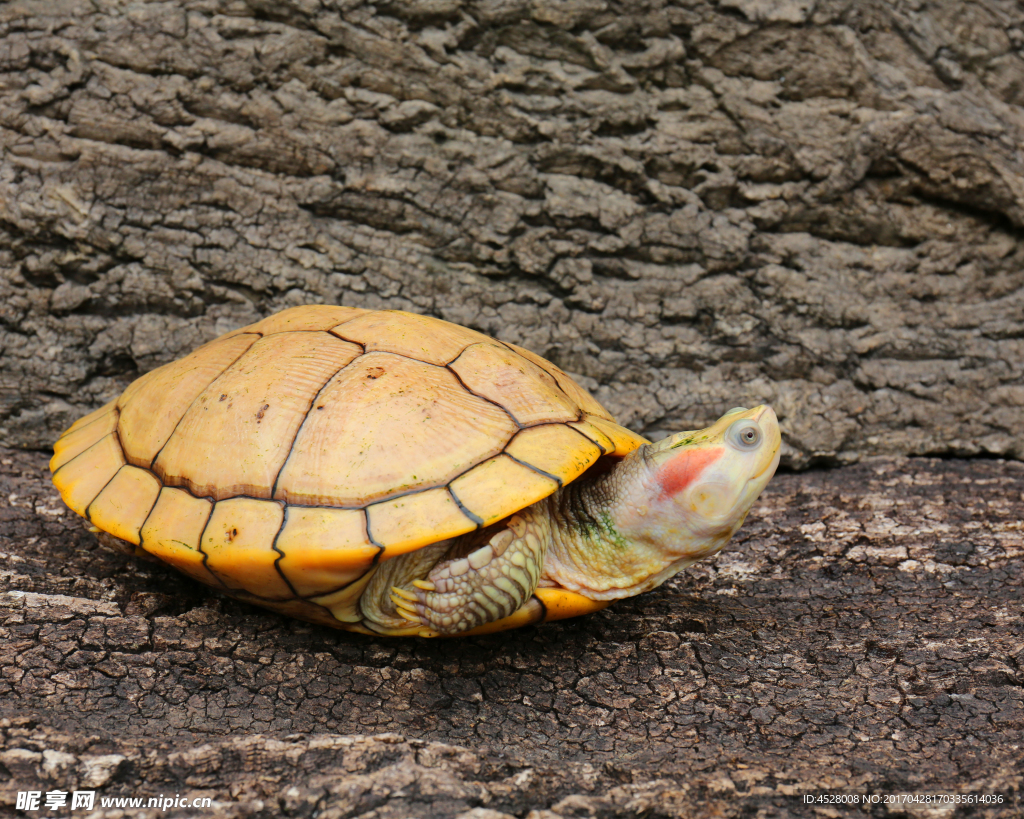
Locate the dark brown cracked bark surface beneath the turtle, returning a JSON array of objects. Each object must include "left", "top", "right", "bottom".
[{"left": 0, "top": 449, "right": 1024, "bottom": 819}]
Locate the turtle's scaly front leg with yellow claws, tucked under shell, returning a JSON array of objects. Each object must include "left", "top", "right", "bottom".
[{"left": 391, "top": 510, "right": 551, "bottom": 636}]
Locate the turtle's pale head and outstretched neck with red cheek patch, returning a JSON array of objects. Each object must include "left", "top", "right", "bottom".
[{"left": 545, "top": 404, "right": 782, "bottom": 601}]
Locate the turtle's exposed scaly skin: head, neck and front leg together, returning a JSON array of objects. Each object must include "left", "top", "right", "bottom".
[{"left": 376, "top": 405, "right": 781, "bottom": 635}]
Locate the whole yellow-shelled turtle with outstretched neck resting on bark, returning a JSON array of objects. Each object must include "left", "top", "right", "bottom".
[{"left": 50, "top": 304, "right": 781, "bottom": 637}]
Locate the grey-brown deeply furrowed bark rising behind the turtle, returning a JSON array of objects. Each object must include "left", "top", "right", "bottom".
[{"left": 0, "top": 0, "right": 1024, "bottom": 466}]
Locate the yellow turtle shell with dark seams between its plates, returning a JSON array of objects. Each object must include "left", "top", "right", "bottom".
[{"left": 50, "top": 305, "right": 645, "bottom": 634}]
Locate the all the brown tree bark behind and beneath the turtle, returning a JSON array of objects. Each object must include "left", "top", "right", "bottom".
[{"left": 0, "top": 0, "right": 1024, "bottom": 819}]
